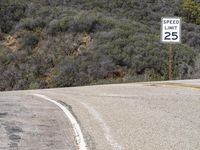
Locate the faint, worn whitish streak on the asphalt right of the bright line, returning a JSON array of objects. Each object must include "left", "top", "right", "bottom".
[{"left": 80, "top": 102, "right": 123, "bottom": 150}]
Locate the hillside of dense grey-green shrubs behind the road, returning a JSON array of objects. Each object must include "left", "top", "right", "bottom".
[{"left": 0, "top": 0, "right": 200, "bottom": 90}]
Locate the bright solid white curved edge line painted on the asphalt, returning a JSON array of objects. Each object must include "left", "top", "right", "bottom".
[{"left": 31, "top": 94, "right": 87, "bottom": 150}]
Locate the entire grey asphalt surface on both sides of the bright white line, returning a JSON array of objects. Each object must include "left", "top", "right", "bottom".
[{"left": 0, "top": 80, "right": 200, "bottom": 150}]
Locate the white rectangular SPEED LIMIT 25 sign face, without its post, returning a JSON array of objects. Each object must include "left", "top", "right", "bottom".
[{"left": 161, "top": 17, "right": 181, "bottom": 43}]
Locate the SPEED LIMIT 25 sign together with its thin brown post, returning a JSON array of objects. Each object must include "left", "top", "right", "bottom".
[{"left": 161, "top": 17, "right": 181, "bottom": 80}]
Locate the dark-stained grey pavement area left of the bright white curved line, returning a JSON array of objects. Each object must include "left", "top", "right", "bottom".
[{"left": 0, "top": 92, "right": 77, "bottom": 150}]
